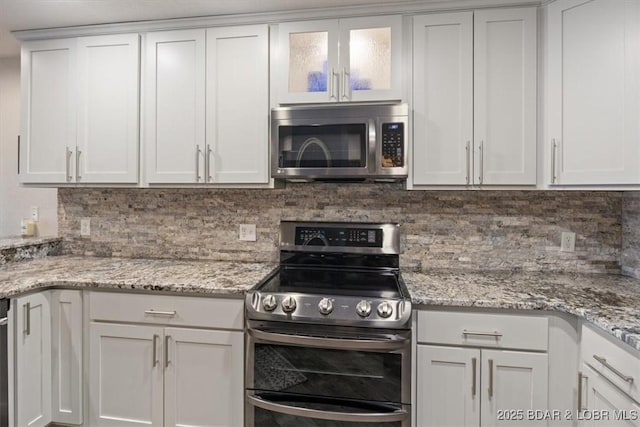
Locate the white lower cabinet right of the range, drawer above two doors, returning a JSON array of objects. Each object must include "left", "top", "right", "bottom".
[{"left": 416, "top": 312, "right": 549, "bottom": 427}]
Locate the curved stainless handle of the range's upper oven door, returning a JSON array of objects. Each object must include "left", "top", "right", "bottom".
[{"left": 248, "top": 328, "right": 410, "bottom": 351}]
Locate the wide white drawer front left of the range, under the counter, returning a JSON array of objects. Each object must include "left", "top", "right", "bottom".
[{"left": 89, "top": 292, "right": 244, "bottom": 329}]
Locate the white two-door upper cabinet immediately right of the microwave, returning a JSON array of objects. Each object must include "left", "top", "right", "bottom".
[{"left": 413, "top": 8, "right": 537, "bottom": 185}]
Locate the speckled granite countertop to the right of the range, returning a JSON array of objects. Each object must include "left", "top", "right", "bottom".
[{"left": 402, "top": 271, "right": 640, "bottom": 350}]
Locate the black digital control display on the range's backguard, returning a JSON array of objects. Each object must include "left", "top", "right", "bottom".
[{"left": 295, "top": 227, "right": 382, "bottom": 248}]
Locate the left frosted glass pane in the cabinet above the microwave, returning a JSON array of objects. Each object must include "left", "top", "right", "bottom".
[{"left": 289, "top": 31, "right": 329, "bottom": 92}]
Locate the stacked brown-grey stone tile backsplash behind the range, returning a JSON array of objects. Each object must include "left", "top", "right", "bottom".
[{"left": 58, "top": 183, "right": 620, "bottom": 273}]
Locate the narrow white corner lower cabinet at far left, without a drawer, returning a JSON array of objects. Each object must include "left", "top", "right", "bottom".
[{"left": 9, "top": 290, "right": 83, "bottom": 427}]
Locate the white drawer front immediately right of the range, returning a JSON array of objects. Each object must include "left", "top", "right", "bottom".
[{"left": 418, "top": 311, "right": 549, "bottom": 351}]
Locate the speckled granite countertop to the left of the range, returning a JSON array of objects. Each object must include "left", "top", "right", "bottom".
[{"left": 0, "top": 256, "right": 275, "bottom": 298}]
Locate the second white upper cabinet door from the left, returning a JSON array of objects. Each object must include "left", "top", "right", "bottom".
[{"left": 75, "top": 34, "right": 140, "bottom": 183}]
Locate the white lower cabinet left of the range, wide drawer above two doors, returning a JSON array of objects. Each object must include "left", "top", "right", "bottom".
[{"left": 88, "top": 293, "right": 244, "bottom": 427}]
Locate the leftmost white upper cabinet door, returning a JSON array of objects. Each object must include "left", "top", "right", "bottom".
[{"left": 20, "top": 39, "right": 76, "bottom": 183}]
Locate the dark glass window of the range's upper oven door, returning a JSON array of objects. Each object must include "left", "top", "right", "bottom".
[{"left": 252, "top": 343, "right": 400, "bottom": 409}]
